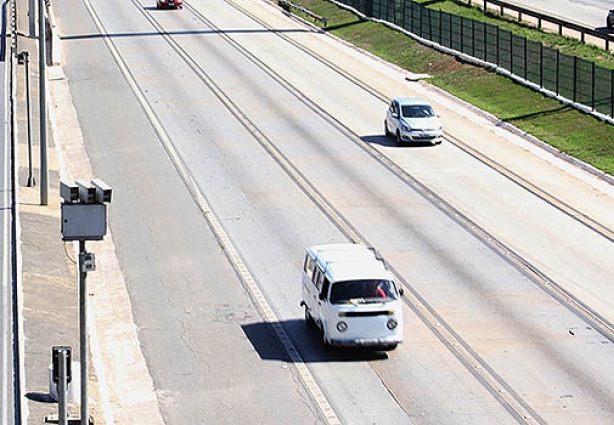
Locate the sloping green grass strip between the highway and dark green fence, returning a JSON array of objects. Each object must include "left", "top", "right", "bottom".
[{"left": 293, "top": 0, "right": 614, "bottom": 175}]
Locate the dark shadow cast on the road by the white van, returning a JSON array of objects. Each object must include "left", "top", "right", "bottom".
[{"left": 241, "top": 319, "right": 388, "bottom": 363}]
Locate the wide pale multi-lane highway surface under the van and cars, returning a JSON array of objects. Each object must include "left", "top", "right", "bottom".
[{"left": 36, "top": 0, "right": 614, "bottom": 424}]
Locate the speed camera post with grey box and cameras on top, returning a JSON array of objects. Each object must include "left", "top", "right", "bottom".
[{"left": 60, "top": 179, "right": 112, "bottom": 425}]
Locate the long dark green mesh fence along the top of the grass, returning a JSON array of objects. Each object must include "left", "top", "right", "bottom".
[{"left": 341, "top": 0, "right": 614, "bottom": 117}]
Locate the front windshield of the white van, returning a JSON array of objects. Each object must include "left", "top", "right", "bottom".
[{"left": 330, "top": 279, "right": 397, "bottom": 304}]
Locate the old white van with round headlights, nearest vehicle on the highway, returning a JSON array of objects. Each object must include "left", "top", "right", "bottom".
[{"left": 301, "top": 243, "right": 403, "bottom": 350}]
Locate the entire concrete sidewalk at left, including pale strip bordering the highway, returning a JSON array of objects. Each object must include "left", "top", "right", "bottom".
[{"left": 16, "top": 0, "right": 163, "bottom": 425}]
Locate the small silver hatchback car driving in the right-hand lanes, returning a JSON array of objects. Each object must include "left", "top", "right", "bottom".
[{"left": 384, "top": 97, "right": 443, "bottom": 145}]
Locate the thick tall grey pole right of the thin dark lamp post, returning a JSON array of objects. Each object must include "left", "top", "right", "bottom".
[{"left": 38, "top": 0, "right": 49, "bottom": 205}]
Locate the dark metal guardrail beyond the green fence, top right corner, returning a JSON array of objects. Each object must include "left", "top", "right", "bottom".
[{"left": 460, "top": 0, "right": 614, "bottom": 50}]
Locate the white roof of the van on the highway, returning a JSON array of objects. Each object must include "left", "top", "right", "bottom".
[{"left": 307, "top": 243, "right": 392, "bottom": 281}]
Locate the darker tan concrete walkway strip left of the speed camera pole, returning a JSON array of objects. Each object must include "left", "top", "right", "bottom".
[{"left": 16, "top": 0, "right": 103, "bottom": 424}]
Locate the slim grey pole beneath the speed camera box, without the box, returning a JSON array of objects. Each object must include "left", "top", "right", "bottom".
[{"left": 79, "top": 240, "right": 89, "bottom": 425}]
